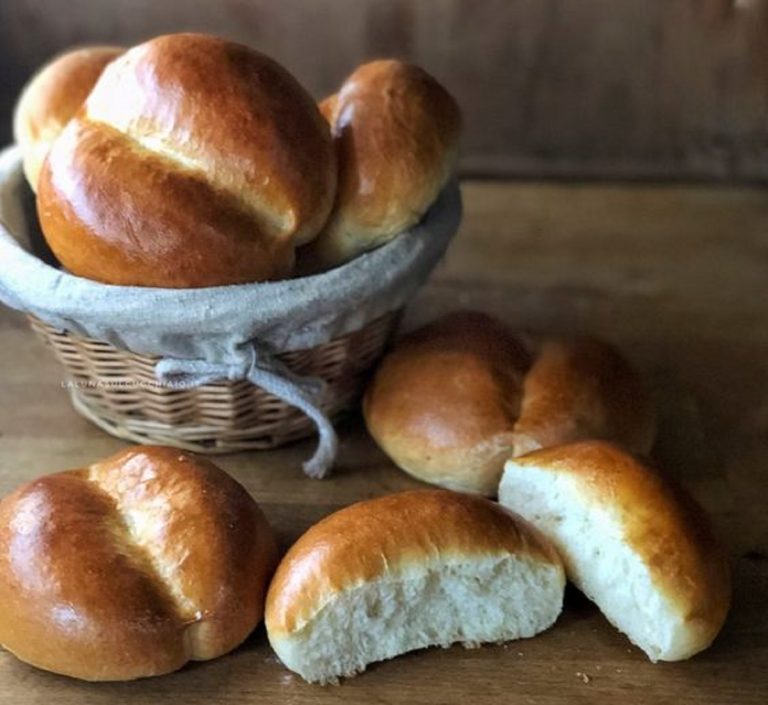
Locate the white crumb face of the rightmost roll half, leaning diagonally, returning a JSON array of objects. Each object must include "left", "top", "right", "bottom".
[{"left": 499, "top": 460, "right": 698, "bottom": 662}]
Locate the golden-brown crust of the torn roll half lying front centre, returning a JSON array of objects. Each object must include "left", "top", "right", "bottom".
[{"left": 264, "top": 490, "right": 561, "bottom": 640}]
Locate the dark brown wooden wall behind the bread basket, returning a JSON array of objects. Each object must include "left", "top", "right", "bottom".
[{"left": 0, "top": 0, "right": 768, "bottom": 180}]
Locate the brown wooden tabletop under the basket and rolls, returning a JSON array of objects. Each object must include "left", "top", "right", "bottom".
[{"left": 0, "top": 183, "right": 768, "bottom": 705}]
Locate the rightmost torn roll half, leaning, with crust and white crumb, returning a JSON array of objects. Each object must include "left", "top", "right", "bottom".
[{"left": 499, "top": 441, "right": 730, "bottom": 661}]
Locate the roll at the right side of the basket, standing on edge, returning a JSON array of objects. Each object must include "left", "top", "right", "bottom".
[{"left": 299, "top": 60, "right": 461, "bottom": 272}]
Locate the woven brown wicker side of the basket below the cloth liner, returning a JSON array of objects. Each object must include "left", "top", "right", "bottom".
[{"left": 29, "top": 311, "right": 400, "bottom": 454}]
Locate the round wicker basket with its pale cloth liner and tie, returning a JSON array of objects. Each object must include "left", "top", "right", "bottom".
[{"left": 0, "top": 146, "right": 462, "bottom": 464}]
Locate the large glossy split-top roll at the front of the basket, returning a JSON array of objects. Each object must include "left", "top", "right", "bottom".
[{"left": 38, "top": 34, "right": 336, "bottom": 288}]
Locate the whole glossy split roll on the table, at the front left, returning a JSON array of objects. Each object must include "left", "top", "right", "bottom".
[{"left": 0, "top": 446, "right": 277, "bottom": 681}]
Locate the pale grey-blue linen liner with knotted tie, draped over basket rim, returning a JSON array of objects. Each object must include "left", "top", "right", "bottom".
[{"left": 0, "top": 146, "right": 461, "bottom": 478}]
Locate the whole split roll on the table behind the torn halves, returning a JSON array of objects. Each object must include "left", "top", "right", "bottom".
[{"left": 363, "top": 311, "right": 654, "bottom": 496}]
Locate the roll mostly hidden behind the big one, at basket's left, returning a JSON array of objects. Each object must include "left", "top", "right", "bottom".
[{"left": 13, "top": 47, "right": 124, "bottom": 191}]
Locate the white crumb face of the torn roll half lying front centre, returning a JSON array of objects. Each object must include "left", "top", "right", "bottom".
[{"left": 270, "top": 554, "right": 565, "bottom": 683}]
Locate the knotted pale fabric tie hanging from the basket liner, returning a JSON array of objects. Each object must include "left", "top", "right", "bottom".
[{"left": 155, "top": 343, "right": 338, "bottom": 480}]
